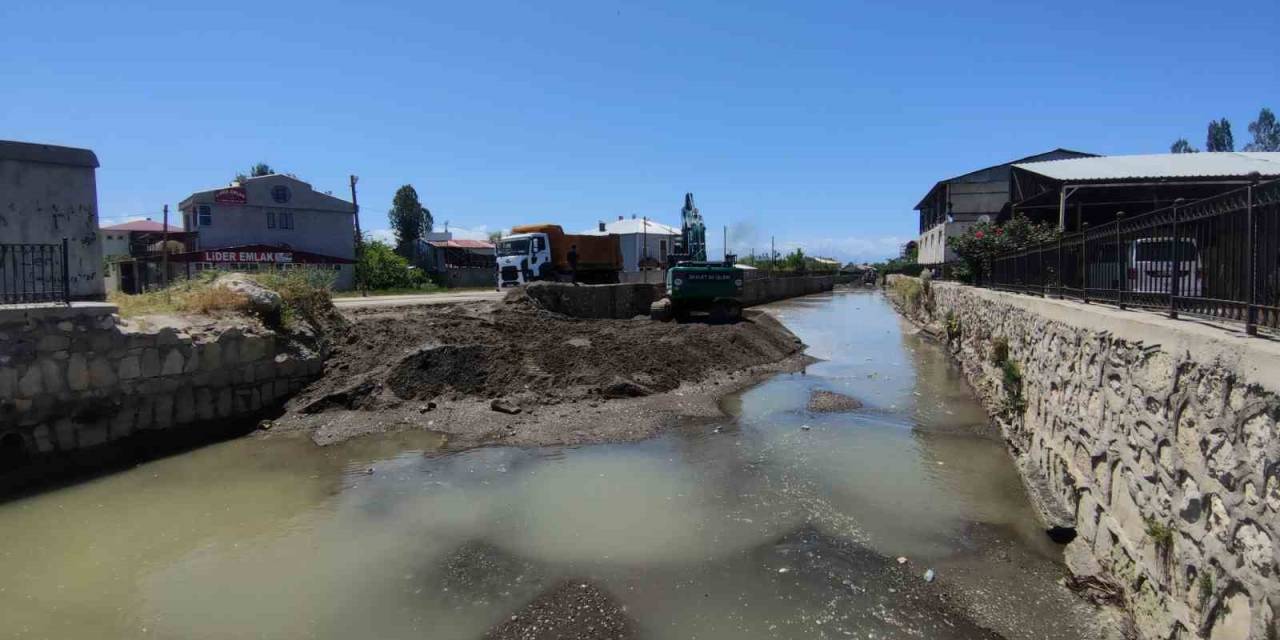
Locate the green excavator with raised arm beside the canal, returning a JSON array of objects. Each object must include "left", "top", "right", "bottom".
[{"left": 650, "top": 193, "right": 744, "bottom": 323}]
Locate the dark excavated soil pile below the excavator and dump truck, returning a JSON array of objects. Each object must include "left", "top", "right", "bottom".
[{"left": 289, "top": 300, "right": 803, "bottom": 415}]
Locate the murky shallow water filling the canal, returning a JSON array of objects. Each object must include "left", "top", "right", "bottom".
[{"left": 0, "top": 292, "right": 1092, "bottom": 639}]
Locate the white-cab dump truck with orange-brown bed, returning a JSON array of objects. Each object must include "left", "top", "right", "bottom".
[{"left": 497, "top": 224, "right": 622, "bottom": 291}]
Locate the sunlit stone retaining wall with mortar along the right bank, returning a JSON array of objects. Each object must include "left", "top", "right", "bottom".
[{"left": 890, "top": 279, "right": 1280, "bottom": 640}]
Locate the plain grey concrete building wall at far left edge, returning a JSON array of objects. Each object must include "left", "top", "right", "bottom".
[{"left": 0, "top": 141, "right": 106, "bottom": 300}]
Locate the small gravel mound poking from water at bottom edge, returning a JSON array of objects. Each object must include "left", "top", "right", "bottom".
[{"left": 484, "top": 581, "right": 636, "bottom": 640}]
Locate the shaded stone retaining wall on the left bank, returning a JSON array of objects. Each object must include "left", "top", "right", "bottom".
[{"left": 0, "top": 303, "right": 323, "bottom": 460}]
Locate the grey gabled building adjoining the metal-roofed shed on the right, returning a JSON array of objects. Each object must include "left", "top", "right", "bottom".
[{"left": 915, "top": 148, "right": 1094, "bottom": 265}]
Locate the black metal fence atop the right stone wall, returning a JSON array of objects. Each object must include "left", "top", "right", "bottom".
[{"left": 982, "top": 180, "right": 1280, "bottom": 334}]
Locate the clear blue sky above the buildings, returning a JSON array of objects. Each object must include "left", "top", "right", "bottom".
[{"left": 0, "top": 0, "right": 1280, "bottom": 259}]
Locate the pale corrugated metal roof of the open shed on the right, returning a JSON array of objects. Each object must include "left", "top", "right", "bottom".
[{"left": 1014, "top": 151, "right": 1280, "bottom": 182}]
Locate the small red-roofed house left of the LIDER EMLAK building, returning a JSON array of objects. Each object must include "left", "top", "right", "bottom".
[{"left": 97, "top": 219, "right": 193, "bottom": 293}]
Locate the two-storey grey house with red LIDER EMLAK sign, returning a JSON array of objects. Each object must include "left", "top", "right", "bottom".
[{"left": 169, "top": 174, "right": 356, "bottom": 289}]
